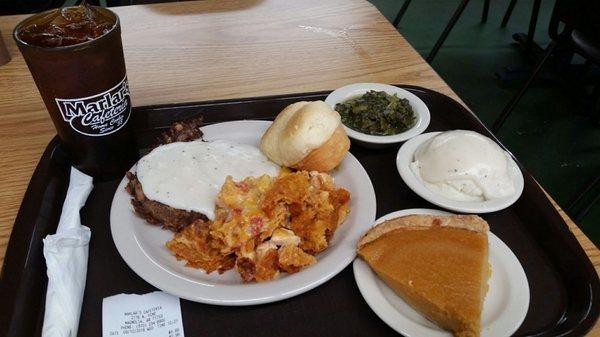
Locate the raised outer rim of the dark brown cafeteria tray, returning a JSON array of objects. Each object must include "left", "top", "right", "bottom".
[{"left": 0, "top": 84, "right": 600, "bottom": 336}]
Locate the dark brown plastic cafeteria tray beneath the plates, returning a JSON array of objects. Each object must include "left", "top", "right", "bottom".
[{"left": 0, "top": 86, "right": 600, "bottom": 337}]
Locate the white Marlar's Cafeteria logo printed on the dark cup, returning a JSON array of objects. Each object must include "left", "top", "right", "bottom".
[{"left": 55, "top": 77, "right": 131, "bottom": 137}]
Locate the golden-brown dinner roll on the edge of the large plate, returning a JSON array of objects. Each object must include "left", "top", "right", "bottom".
[{"left": 260, "top": 101, "right": 350, "bottom": 172}]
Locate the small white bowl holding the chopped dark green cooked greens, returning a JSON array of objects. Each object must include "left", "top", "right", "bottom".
[{"left": 325, "top": 83, "right": 431, "bottom": 148}]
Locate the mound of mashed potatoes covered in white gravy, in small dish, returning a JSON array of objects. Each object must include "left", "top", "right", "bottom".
[{"left": 411, "top": 130, "right": 515, "bottom": 201}]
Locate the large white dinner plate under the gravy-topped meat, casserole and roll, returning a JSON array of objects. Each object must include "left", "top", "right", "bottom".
[{"left": 110, "top": 121, "right": 376, "bottom": 305}]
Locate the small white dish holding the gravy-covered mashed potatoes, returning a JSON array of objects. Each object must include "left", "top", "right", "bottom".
[{"left": 396, "top": 132, "right": 524, "bottom": 213}]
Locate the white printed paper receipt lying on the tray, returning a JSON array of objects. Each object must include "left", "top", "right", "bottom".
[{"left": 102, "top": 291, "right": 184, "bottom": 337}]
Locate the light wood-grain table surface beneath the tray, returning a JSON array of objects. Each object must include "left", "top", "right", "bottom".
[{"left": 0, "top": 0, "right": 600, "bottom": 335}]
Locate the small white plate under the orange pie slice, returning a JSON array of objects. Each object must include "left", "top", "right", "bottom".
[{"left": 353, "top": 209, "right": 529, "bottom": 337}]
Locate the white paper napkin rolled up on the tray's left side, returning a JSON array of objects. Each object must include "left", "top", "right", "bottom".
[{"left": 42, "top": 168, "right": 93, "bottom": 337}]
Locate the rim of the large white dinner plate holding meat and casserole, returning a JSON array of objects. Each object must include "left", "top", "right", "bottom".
[{"left": 110, "top": 120, "right": 377, "bottom": 306}]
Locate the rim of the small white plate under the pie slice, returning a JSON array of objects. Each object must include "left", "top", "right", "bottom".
[{"left": 352, "top": 208, "right": 531, "bottom": 337}]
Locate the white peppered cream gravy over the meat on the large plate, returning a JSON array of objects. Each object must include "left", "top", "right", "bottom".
[{"left": 136, "top": 140, "right": 280, "bottom": 220}]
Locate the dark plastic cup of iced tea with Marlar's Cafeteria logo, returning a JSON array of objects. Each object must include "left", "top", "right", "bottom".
[{"left": 13, "top": 3, "right": 137, "bottom": 180}]
